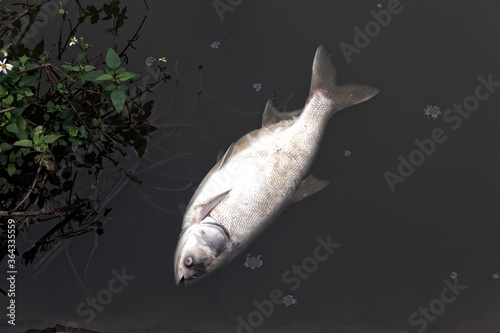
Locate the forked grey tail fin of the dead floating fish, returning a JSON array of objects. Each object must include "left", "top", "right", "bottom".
[{"left": 308, "top": 46, "right": 379, "bottom": 117}]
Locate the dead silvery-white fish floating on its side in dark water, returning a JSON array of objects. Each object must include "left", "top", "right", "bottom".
[{"left": 174, "top": 46, "right": 379, "bottom": 284}]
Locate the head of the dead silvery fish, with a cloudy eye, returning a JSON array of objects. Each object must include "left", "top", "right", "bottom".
[{"left": 174, "top": 217, "right": 232, "bottom": 285}]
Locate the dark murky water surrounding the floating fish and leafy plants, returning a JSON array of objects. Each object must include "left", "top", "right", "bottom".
[{"left": 0, "top": 0, "right": 500, "bottom": 333}]
